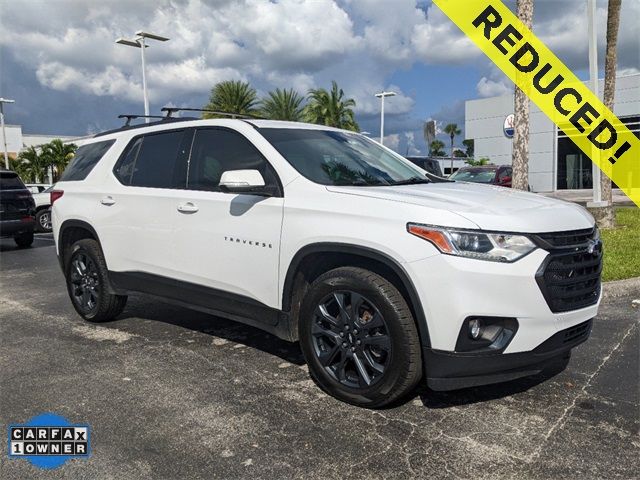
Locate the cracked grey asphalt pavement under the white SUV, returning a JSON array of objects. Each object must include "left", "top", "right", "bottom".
[{"left": 0, "top": 235, "right": 640, "bottom": 479}]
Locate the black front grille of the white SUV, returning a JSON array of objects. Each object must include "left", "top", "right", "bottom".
[{"left": 535, "top": 229, "right": 602, "bottom": 313}]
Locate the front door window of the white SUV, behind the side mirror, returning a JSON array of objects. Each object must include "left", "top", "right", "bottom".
[{"left": 187, "top": 129, "right": 278, "bottom": 191}]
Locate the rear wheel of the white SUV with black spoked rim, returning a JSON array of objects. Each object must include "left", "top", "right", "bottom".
[{"left": 65, "top": 239, "right": 127, "bottom": 323}]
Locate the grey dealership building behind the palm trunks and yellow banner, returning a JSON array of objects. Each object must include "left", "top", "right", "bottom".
[{"left": 465, "top": 74, "right": 640, "bottom": 192}]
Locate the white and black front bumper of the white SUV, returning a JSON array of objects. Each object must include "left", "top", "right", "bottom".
[{"left": 404, "top": 244, "right": 600, "bottom": 390}]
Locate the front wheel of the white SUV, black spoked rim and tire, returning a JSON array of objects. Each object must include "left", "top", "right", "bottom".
[{"left": 299, "top": 267, "right": 422, "bottom": 408}]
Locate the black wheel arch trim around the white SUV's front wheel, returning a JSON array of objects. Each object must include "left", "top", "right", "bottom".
[{"left": 282, "top": 242, "right": 431, "bottom": 348}]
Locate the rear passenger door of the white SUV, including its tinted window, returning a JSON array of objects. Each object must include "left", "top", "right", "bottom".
[{"left": 95, "top": 129, "right": 193, "bottom": 277}]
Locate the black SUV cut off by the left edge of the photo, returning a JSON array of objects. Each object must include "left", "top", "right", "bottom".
[{"left": 0, "top": 169, "right": 36, "bottom": 247}]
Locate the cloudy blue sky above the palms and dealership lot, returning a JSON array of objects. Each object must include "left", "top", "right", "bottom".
[{"left": 0, "top": 0, "right": 640, "bottom": 153}]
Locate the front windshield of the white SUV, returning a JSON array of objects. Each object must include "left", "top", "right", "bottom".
[{"left": 260, "top": 128, "right": 429, "bottom": 186}]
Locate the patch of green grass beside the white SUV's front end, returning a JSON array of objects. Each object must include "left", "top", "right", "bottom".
[{"left": 601, "top": 207, "right": 640, "bottom": 282}]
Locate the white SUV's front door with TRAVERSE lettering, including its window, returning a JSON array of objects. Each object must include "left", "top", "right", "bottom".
[{"left": 175, "top": 127, "right": 284, "bottom": 313}]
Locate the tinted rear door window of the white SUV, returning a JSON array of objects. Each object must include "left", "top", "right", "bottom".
[{"left": 113, "top": 130, "right": 187, "bottom": 188}]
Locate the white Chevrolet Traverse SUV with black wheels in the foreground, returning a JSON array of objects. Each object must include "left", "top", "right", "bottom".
[{"left": 52, "top": 119, "right": 602, "bottom": 407}]
